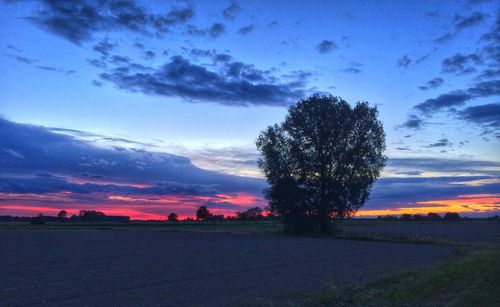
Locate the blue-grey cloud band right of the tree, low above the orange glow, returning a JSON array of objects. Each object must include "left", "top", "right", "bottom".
[{"left": 365, "top": 158, "right": 500, "bottom": 209}]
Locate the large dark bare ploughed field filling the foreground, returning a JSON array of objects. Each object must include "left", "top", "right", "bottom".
[{"left": 0, "top": 230, "right": 450, "bottom": 306}]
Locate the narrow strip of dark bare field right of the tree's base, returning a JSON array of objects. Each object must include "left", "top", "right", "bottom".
[{"left": 342, "top": 221, "right": 500, "bottom": 243}]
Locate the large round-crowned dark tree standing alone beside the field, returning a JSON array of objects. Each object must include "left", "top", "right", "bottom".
[{"left": 257, "top": 95, "right": 386, "bottom": 232}]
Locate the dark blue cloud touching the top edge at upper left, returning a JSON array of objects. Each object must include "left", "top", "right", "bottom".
[{"left": 10, "top": 0, "right": 194, "bottom": 44}]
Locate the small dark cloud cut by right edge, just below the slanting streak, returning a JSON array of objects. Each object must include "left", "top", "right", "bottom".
[{"left": 457, "top": 103, "right": 500, "bottom": 128}]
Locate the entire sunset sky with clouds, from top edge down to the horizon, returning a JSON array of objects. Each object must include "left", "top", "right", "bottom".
[{"left": 0, "top": 0, "right": 500, "bottom": 219}]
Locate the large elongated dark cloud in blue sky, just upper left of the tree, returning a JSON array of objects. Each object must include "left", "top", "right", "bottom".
[{"left": 100, "top": 56, "right": 306, "bottom": 106}]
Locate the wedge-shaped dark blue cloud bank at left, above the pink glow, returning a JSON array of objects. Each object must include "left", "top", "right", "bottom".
[{"left": 0, "top": 119, "right": 265, "bottom": 195}]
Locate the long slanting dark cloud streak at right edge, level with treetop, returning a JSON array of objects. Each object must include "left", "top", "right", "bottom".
[{"left": 413, "top": 80, "right": 500, "bottom": 115}]
